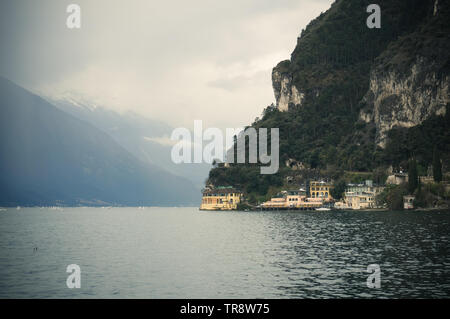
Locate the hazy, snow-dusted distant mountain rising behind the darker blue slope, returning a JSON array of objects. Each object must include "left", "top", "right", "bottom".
[{"left": 47, "top": 97, "right": 211, "bottom": 191}]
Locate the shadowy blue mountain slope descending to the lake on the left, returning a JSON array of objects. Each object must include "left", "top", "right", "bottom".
[{"left": 0, "top": 78, "right": 200, "bottom": 206}]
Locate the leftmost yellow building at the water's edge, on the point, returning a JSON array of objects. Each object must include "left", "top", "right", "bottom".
[{"left": 200, "top": 187, "right": 242, "bottom": 210}]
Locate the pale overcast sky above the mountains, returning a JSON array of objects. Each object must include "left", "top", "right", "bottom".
[{"left": 0, "top": 0, "right": 333, "bottom": 128}]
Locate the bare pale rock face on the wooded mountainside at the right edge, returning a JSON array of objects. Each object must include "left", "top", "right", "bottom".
[{"left": 360, "top": 56, "right": 450, "bottom": 148}]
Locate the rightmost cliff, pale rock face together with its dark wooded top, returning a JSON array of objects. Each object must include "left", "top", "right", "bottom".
[{"left": 360, "top": 0, "right": 450, "bottom": 148}]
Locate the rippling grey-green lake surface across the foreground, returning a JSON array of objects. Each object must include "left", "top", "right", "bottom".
[{"left": 0, "top": 207, "right": 450, "bottom": 298}]
